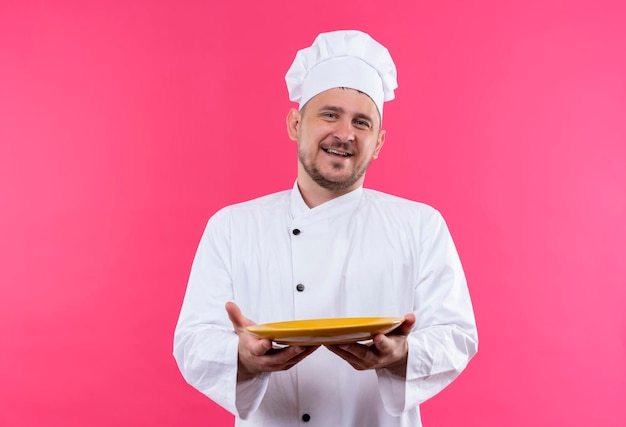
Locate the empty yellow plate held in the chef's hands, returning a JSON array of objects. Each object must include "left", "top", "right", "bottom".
[{"left": 246, "top": 317, "right": 404, "bottom": 345}]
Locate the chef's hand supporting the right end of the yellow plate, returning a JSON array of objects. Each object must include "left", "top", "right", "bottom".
[{"left": 327, "top": 314, "right": 415, "bottom": 377}]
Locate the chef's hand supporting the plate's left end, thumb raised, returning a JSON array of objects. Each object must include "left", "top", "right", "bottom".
[{"left": 226, "top": 302, "right": 319, "bottom": 381}]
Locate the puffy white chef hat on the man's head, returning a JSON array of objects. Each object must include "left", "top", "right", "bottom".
[{"left": 285, "top": 30, "right": 398, "bottom": 118}]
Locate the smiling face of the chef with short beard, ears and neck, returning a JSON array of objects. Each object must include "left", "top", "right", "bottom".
[{"left": 287, "top": 88, "right": 385, "bottom": 204}]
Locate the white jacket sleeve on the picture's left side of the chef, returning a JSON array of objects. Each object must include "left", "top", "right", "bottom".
[{"left": 174, "top": 212, "right": 268, "bottom": 419}]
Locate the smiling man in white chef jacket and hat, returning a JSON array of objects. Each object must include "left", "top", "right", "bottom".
[{"left": 174, "top": 31, "right": 477, "bottom": 427}]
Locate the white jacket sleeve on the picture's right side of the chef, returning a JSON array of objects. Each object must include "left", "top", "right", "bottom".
[{"left": 377, "top": 211, "right": 478, "bottom": 415}]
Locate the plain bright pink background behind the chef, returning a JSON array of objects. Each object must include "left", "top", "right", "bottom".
[{"left": 0, "top": 0, "right": 626, "bottom": 427}]
